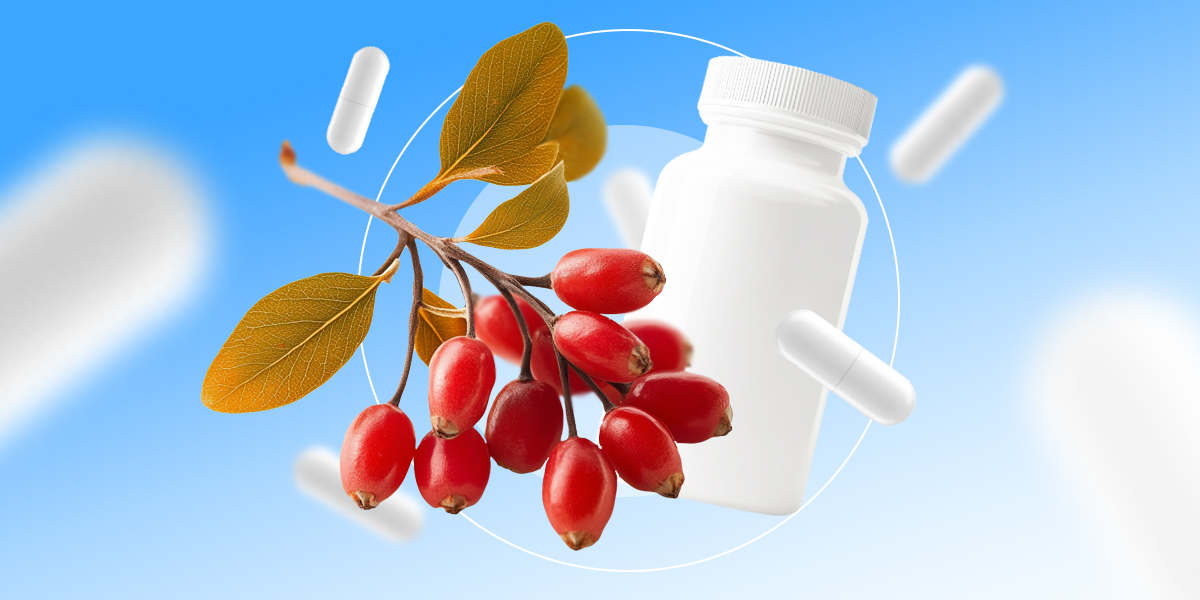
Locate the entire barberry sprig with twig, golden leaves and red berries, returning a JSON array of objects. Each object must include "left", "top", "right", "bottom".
[{"left": 200, "top": 23, "right": 732, "bottom": 550}]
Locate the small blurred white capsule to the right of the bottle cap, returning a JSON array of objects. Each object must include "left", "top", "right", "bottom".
[{"left": 889, "top": 65, "right": 1004, "bottom": 184}]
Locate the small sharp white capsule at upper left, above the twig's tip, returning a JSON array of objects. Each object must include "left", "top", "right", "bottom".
[{"left": 325, "top": 46, "right": 391, "bottom": 154}]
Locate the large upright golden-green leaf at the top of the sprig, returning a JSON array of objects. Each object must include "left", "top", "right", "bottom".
[{"left": 434, "top": 23, "right": 566, "bottom": 186}]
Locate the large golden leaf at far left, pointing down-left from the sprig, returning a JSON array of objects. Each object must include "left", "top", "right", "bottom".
[{"left": 200, "top": 262, "right": 400, "bottom": 413}]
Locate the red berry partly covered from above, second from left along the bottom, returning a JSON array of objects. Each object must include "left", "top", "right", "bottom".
[{"left": 413, "top": 428, "right": 492, "bottom": 515}]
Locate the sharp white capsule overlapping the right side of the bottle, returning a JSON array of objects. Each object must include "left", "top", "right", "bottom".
[{"left": 775, "top": 310, "right": 917, "bottom": 425}]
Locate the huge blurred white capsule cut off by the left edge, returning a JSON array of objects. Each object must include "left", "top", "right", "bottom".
[{"left": 0, "top": 139, "right": 211, "bottom": 440}]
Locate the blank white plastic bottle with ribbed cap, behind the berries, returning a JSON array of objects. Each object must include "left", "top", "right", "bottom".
[{"left": 631, "top": 56, "right": 875, "bottom": 515}]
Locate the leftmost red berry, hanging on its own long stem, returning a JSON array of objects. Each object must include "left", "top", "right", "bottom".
[{"left": 341, "top": 404, "right": 416, "bottom": 510}]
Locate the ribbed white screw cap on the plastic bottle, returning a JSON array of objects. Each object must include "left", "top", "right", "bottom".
[{"left": 700, "top": 56, "right": 876, "bottom": 145}]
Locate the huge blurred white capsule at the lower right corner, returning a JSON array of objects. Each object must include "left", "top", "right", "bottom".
[{"left": 1033, "top": 293, "right": 1200, "bottom": 599}]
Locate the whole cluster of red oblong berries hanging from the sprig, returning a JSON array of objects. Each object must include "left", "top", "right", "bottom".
[{"left": 342, "top": 248, "right": 732, "bottom": 550}]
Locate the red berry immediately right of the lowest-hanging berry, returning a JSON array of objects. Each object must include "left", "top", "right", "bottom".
[{"left": 600, "top": 407, "right": 683, "bottom": 498}]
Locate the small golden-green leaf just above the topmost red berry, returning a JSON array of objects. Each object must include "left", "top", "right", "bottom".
[{"left": 455, "top": 163, "right": 571, "bottom": 250}]
